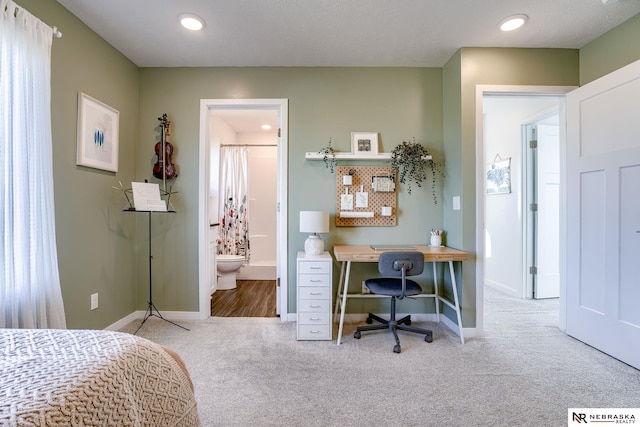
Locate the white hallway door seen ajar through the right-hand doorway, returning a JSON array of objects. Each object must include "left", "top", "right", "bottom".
[{"left": 533, "top": 124, "right": 560, "bottom": 298}]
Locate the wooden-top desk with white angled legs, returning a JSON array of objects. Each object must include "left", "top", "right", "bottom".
[{"left": 333, "top": 245, "right": 469, "bottom": 345}]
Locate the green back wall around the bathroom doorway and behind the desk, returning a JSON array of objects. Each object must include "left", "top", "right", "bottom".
[{"left": 136, "top": 67, "right": 443, "bottom": 312}]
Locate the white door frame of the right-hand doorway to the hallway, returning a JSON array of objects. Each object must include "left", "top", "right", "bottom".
[{"left": 475, "top": 85, "right": 576, "bottom": 336}]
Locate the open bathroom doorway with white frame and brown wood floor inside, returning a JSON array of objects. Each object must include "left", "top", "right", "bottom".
[{"left": 199, "top": 99, "right": 288, "bottom": 320}]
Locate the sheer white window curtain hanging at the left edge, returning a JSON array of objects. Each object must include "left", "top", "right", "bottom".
[{"left": 0, "top": 0, "right": 66, "bottom": 328}]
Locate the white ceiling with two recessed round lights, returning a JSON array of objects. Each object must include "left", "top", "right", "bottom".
[{"left": 57, "top": 0, "right": 640, "bottom": 67}]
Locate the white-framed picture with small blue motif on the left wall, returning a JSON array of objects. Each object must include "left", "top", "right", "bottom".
[{"left": 76, "top": 92, "right": 120, "bottom": 172}]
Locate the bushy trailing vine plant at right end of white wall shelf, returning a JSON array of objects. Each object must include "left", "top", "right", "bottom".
[{"left": 390, "top": 138, "right": 443, "bottom": 205}]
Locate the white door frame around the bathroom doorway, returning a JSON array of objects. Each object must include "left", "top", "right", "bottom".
[{"left": 198, "top": 99, "right": 289, "bottom": 321}]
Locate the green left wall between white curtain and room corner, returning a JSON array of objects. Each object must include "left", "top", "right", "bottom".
[{"left": 16, "top": 0, "right": 140, "bottom": 329}]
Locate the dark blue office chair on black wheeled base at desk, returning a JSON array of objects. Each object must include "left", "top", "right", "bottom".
[{"left": 353, "top": 251, "right": 433, "bottom": 353}]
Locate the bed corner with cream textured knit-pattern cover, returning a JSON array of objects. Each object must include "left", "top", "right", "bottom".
[{"left": 0, "top": 329, "right": 201, "bottom": 427}]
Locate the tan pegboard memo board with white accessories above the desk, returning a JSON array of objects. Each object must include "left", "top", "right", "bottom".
[{"left": 336, "top": 166, "right": 396, "bottom": 227}]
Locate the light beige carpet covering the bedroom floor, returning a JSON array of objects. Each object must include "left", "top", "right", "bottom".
[{"left": 125, "top": 290, "right": 640, "bottom": 426}]
